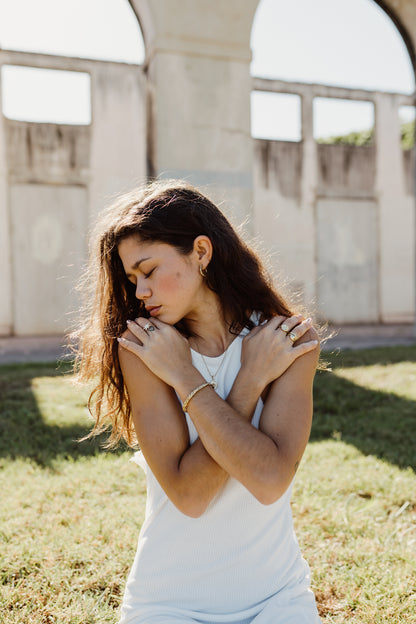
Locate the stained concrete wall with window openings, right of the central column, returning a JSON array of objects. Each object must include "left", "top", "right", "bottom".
[{"left": 254, "top": 79, "right": 416, "bottom": 324}]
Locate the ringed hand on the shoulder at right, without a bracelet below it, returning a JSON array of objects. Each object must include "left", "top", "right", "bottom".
[{"left": 241, "top": 314, "right": 318, "bottom": 390}]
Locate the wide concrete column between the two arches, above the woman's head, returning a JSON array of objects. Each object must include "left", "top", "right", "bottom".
[{"left": 132, "top": 0, "right": 258, "bottom": 232}]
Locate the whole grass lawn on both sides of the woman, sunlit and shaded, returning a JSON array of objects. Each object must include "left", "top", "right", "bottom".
[{"left": 0, "top": 347, "right": 416, "bottom": 624}]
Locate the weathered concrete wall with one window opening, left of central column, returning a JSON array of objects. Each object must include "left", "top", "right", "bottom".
[{"left": 0, "top": 50, "right": 147, "bottom": 335}]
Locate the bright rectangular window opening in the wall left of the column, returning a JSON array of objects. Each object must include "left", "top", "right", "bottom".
[{"left": 1, "top": 65, "right": 91, "bottom": 125}]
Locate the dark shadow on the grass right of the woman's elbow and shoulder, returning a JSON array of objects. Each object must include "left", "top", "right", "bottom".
[{"left": 310, "top": 347, "right": 416, "bottom": 470}]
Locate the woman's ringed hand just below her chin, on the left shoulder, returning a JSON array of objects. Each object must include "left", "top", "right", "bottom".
[{"left": 118, "top": 317, "right": 193, "bottom": 387}]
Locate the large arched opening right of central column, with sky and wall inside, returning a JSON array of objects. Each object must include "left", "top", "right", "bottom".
[{"left": 252, "top": 0, "right": 415, "bottom": 324}]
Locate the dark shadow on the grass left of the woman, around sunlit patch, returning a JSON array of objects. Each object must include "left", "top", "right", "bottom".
[{"left": 0, "top": 362, "right": 126, "bottom": 467}]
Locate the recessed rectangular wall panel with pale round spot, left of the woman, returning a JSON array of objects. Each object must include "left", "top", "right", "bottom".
[{"left": 9, "top": 184, "right": 88, "bottom": 336}]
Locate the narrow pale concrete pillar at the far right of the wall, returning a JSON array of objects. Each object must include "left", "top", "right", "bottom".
[{"left": 375, "top": 93, "right": 415, "bottom": 323}]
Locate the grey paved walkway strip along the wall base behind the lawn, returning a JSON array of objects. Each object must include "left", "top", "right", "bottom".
[{"left": 0, "top": 325, "right": 416, "bottom": 364}]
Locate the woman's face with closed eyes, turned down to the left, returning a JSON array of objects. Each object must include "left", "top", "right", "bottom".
[{"left": 118, "top": 236, "right": 205, "bottom": 325}]
